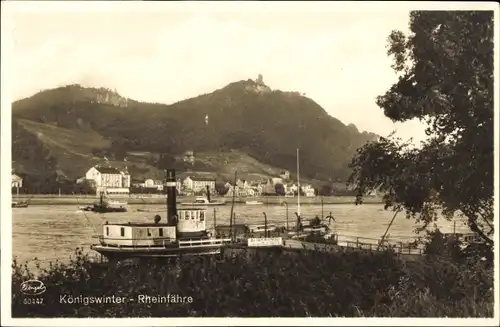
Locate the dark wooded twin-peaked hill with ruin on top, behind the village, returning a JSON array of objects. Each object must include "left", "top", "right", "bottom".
[{"left": 12, "top": 80, "right": 376, "bottom": 192}]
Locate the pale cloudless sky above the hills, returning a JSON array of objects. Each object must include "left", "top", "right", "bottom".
[{"left": 5, "top": 2, "right": 425, "bottom": 142}]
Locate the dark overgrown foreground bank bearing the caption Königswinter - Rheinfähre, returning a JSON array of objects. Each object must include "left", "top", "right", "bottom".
[{"left": 12, "top": 247, "right": 493, "bottom": 317}]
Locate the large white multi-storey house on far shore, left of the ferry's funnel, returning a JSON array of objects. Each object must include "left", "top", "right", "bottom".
[{"left": 85, "top": 166, "right": 130, "bottom": 194}]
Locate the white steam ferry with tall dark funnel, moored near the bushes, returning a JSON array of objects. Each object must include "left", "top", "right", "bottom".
[{"left": 91, "top": 170, "right": 231, "bottom": 260}]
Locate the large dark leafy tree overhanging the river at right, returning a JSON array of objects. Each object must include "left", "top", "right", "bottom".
[{"left": 349, "top": 11, "right": 493, "bottom": 245}]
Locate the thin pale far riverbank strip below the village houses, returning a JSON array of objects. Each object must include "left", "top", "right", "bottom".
[{"left": 12, "top": 194, "right": 382, "bottom": 205}]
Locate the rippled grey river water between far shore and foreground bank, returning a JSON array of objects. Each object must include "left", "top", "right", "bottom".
[{"left": 12, "top": 204, "right": 468, "bottom": 267}]
